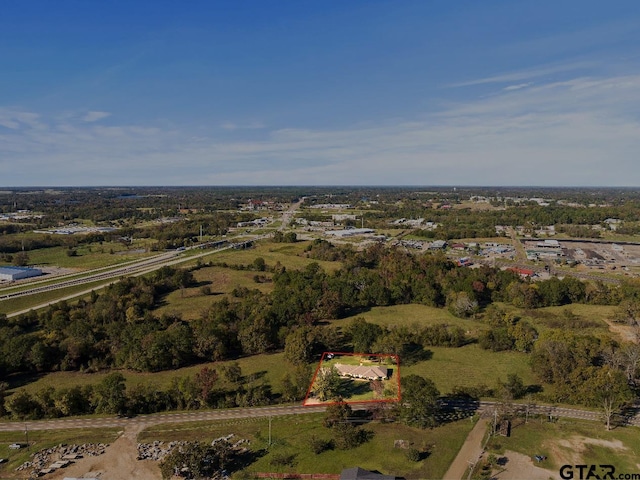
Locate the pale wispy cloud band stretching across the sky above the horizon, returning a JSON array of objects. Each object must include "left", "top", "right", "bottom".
[{"left": 0, "top": 74, "right": 640, "bottom": 186}]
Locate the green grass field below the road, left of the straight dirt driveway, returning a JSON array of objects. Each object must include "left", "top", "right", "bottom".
[{"left": 138, "top": 414, "right": 473, "bottom": 479}]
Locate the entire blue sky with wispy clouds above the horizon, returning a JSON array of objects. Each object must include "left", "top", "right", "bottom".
[{"left": 0, "top": 0, "right": 640, "bottom": 187}]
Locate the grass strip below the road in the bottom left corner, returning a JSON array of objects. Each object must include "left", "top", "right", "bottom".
[{"left": 0, "top": 428, "right": 118, "bottom": 479}]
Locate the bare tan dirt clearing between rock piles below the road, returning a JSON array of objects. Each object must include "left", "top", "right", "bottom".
[{"left": 44, "top": 425, "right": 162, "bottom": 480}]
